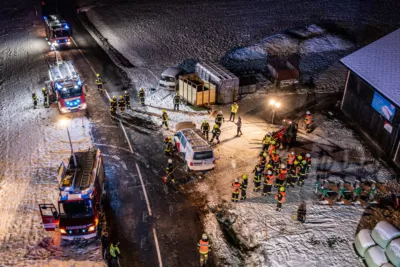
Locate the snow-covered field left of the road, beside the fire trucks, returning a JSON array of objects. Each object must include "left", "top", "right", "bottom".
[{"left": 0, "top": 1, "right": 104, "bottom": 267}]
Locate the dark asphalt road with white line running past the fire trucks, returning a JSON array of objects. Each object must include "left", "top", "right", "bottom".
[{"left": 46, "top": 0, "right": 213, "bottom": 266}]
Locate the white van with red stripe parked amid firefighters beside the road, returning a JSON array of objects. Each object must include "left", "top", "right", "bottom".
[{"left": 174, "top": 129, "right": 215, "bottom": 172}]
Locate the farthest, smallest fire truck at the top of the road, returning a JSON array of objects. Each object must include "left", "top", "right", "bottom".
[{"left": 43, "top": 15, "right": 71, "bottom": 46}]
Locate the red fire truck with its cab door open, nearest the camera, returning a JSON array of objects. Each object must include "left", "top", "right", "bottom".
[{"left": 39, "top": 148, "right": 106, "bottom": 240}]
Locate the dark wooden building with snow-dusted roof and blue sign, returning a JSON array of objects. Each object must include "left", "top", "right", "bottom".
[{"left": 340, "top": 29, "right": 400, "bottom": 166}]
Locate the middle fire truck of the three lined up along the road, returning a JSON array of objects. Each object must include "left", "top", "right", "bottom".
[{"left": 46, "top": 58, "right": 87, "bottom": 113}]
